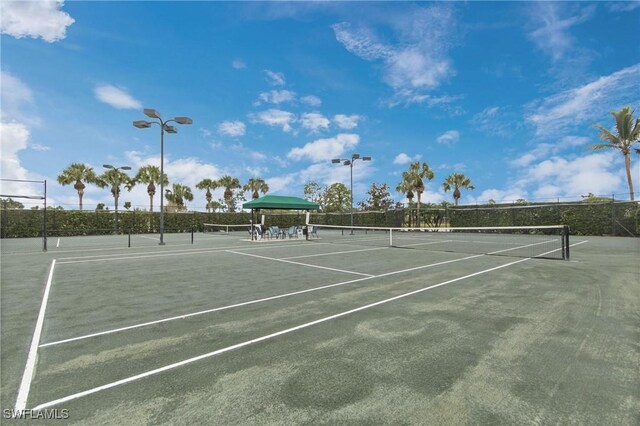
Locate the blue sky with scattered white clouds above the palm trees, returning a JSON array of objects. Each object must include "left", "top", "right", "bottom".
[{"left": 1, "top": 1, "right": 640, "bottom": 209}]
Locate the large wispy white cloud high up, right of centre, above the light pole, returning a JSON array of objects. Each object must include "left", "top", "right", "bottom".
[{"left": 332, "top": 4, "right": 456, "bottom": 105}]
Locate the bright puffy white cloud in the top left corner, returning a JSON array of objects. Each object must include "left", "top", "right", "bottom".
[{"left": 0, "top": 0, "right": 75, "bottom": 43}]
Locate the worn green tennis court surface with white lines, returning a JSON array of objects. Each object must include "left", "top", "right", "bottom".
[{"left": 1, "top": 233, "right": 640, "bottom": 424}]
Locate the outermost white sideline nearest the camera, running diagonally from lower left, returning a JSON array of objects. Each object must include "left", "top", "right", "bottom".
[{"left": 32, "top": 258, "right": 530, "bottom": 410}]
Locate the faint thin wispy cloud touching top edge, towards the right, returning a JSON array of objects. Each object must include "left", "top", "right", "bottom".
[{"left": 529, "top": 2, "right": 595, "bottom": 61}]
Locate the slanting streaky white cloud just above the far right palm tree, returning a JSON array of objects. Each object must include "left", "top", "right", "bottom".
[{"left": 526, "top": 64, "right": 640, "bottom": 136}]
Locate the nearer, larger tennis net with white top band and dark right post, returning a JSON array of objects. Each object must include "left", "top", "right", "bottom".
[{"left": 308, "top": 224, "right": 569, "bottom": 260}]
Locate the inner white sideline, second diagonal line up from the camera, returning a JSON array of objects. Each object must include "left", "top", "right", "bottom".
[{"left": 40, "top": 254, "right": 483, "bottom": 348}]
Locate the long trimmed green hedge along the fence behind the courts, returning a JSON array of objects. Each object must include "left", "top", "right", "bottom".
[{"left": 0, "top": 202, "right": 640, "bottom": 238}]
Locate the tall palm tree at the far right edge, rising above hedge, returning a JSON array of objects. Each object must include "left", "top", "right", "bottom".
[{"left": 591, "top": 106, "right": 640, "bottom": 201}]
